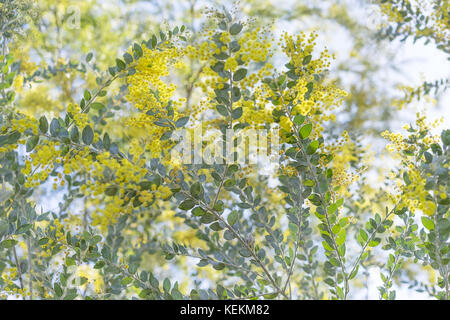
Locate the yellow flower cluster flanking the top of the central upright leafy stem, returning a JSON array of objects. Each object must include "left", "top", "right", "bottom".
[{"left": 186, "top": 27, "right": 273, "bottom": 127}]
